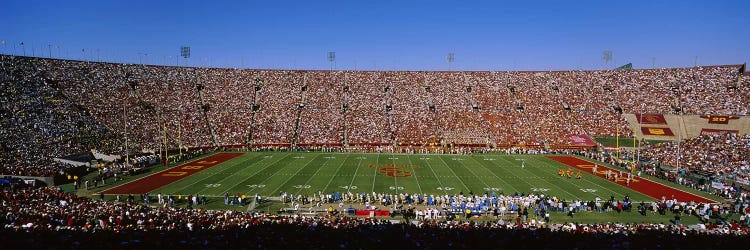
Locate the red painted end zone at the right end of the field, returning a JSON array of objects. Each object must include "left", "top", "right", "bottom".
[{"left": 547, "top": 156, "right": 716, "bottom": 203}]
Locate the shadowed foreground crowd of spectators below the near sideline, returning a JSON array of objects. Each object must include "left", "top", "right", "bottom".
[{"left": 0, "top": 188, "right": 749, "bottom": 249}]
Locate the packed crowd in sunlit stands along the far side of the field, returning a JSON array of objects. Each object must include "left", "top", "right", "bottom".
[{"left": 0, "top": 56, "right": 750, "bottom": 179}]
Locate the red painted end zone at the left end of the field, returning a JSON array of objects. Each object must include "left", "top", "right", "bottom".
[{"left": 104, "top": 153, "right": 243, "bottom": 194}]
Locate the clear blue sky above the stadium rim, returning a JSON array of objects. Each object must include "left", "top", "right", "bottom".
[{"left": 0, "top": 0, "right": 750, "bottom": 70}]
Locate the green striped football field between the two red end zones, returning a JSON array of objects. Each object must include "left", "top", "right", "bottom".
[{"left": 151, "top": 152, "right": 668, "bottom": 201}]
